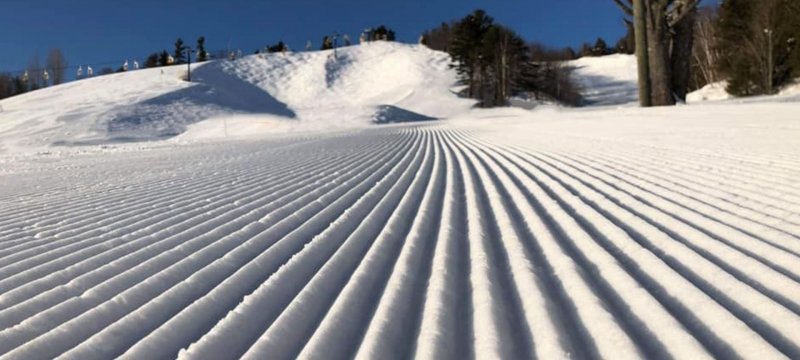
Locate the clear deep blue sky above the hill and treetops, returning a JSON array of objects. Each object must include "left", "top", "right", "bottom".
[{"left": 0, "top": 0, "right": 712, "bottom": 72}]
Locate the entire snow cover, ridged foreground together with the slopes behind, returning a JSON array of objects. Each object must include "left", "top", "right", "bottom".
[{"left": 0, "top": 44, "right": 800, "bottom": 359}]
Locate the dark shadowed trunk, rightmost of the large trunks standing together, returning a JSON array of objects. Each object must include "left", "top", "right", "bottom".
[{"left": 671, "top": 10, "right": 695, "bottom": 102}]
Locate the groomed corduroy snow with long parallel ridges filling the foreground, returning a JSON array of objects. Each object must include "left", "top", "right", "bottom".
[{"left": 0, "top": 112, "right": 800, "bottom": 359}]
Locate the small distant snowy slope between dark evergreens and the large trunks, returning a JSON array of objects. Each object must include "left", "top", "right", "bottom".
[{"left": 567, "top": 54, "right": 639, "bottom": 106}]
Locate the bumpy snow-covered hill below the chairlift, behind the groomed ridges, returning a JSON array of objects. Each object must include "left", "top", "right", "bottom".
[{"left": 0, "top": 42, "right": 472, "bottom": 151}]
